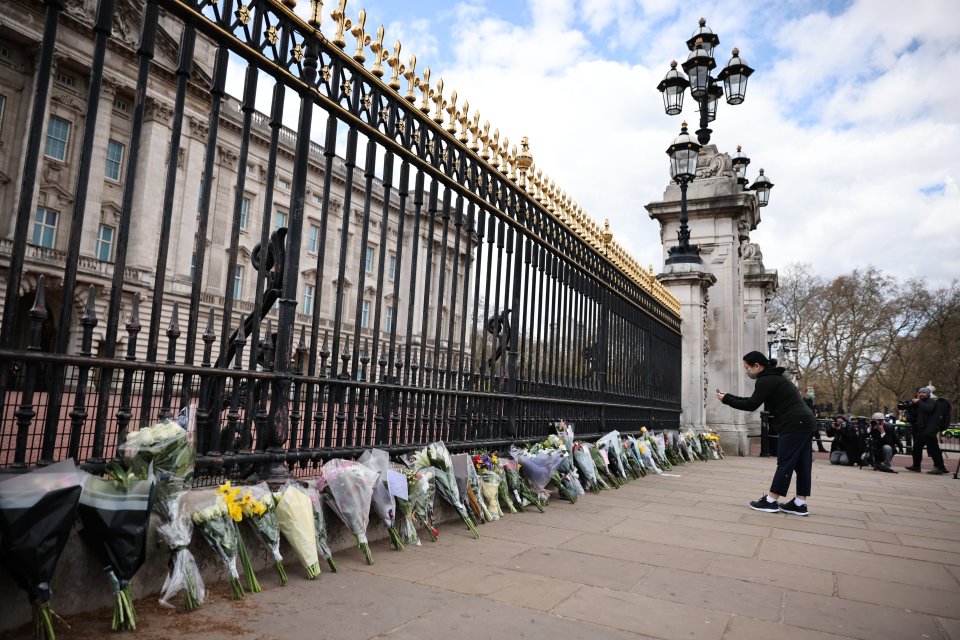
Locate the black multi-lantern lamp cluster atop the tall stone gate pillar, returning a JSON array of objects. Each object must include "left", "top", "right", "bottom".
[{"left": 657, "top": 18, "right": 753, "bottom": 144}]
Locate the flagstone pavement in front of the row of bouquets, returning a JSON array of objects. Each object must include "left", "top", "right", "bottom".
[{"left": 35, "top": 457, "right": 960, "bottom": 640}]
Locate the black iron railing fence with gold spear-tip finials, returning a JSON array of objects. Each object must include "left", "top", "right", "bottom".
[{"left": 0, "top": 0, "right": 680, "bottom": 475}]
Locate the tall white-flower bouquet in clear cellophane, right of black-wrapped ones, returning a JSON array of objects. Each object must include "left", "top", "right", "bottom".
[{"left": 119, "top": 405, "right": 206, "bottom": 611}]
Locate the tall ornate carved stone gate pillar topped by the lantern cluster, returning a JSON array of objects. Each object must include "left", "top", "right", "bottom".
[{"left": 646, "top": 145, "right": 777, "bottom": 455}]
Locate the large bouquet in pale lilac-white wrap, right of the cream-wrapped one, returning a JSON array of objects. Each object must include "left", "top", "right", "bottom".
[{"left": 318, "top": 458, "right": 379, "bottom": 564}]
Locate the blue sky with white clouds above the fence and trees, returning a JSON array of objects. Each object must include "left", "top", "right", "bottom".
[{"left": 284, "top": 0, "right": 960, "bottom": 286}]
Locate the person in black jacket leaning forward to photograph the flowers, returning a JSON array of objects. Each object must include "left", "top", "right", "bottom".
[{"left": 717, "top": 351, "right": 817, "bottom": 516}]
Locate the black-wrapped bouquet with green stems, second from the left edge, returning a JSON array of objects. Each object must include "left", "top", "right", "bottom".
[{"left": 77, "top": 465, "right": 156, "bottom": 631}]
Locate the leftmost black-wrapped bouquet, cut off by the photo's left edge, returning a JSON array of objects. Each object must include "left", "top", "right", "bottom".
[{"left": 0, "top": 459, "right": 88, "bottom": 638}]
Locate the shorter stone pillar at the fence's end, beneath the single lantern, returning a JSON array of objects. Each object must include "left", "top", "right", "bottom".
[{"left": 657, "top": 264, "right": 717, "bottom": 431}]
